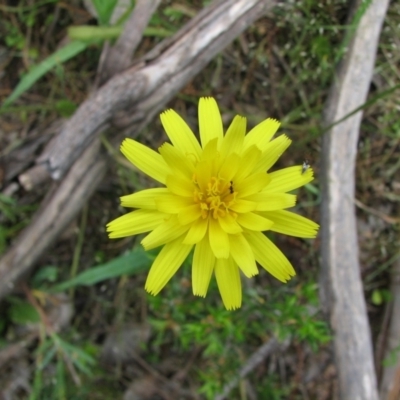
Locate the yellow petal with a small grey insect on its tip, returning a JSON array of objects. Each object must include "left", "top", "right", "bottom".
[{"left": 268, "top": 165, "right": 314, "bottom": 192}]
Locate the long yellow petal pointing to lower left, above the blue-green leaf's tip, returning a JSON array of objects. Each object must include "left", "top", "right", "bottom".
[{"left": 145, "top": 237, "right": 193, "bottom": 296}]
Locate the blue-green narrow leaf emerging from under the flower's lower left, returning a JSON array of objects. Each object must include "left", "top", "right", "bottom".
[{"left": 51, "top": 247, "right": 152, "bottom": 292}]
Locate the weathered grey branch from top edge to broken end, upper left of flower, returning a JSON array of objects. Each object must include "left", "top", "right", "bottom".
[{"left": 41, "top": 0, "right": 275, "bottom": 179}]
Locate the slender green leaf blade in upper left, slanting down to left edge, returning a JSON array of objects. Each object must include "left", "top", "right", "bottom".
[{"left": 0, "top": 41, "right": 88, "bottom": 110}]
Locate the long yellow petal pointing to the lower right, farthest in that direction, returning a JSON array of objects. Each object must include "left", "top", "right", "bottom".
[{"left": 244, "top": 231, "right": 296, "bottom": 282}]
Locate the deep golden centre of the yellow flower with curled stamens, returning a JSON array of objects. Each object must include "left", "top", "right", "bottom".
[{"left": 194, "top": 177, "right": 236, "bottom": 219}]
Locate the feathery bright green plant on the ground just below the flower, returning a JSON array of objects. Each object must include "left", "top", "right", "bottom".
[{"left": 148, "top": 255, "right": 331, "bottom": 399}]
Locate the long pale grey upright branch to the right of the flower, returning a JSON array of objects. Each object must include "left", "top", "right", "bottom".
[{"left": 321, "top": 0, "right": 389, "bottom": 400}]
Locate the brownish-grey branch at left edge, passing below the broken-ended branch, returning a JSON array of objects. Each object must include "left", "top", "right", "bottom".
[{"left": 0, "top": 139, "right": 106, "bottom": 294}]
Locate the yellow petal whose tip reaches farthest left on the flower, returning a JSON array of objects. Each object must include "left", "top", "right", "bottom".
[{"left": 107, "top": 210, "right": 167, "bottom": 239}]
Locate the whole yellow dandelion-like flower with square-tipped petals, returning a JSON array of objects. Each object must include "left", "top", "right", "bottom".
[{"left": 107, "top": 97, "right": 318, "bottom": 310}]
